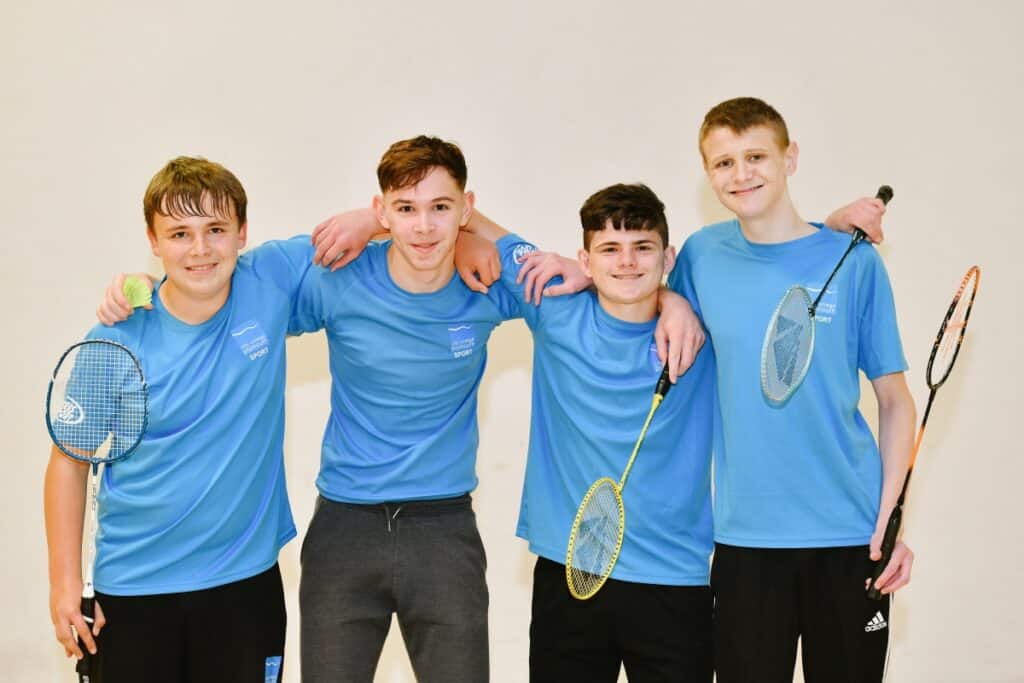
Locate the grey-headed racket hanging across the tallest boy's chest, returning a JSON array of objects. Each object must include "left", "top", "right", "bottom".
[{"left": 761, "top": 185, "right": 893, "bottom": 405}]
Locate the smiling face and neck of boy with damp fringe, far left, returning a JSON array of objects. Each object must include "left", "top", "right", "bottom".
[{"left": 148, "top": 196, "right": 246, "bottom": 323}]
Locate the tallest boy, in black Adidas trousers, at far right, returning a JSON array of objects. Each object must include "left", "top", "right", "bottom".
[{"left": 670, "top": 97, "right": 914, "bottom": 683}]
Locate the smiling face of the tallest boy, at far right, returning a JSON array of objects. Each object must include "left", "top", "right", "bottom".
[{"left": 700, "top": 125, "right": 799, "bottom": 222}]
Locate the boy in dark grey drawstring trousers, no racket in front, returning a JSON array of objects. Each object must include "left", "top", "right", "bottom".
[{"left": 292, "top": 136, "right": 519, "bottom": 682}]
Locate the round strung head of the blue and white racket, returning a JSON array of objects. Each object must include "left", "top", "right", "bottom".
[{"left": 48, "top": 342, "right": 146, "bottom": 463}]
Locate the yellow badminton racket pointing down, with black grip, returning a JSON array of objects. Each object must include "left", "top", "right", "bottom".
[{"left": 565, "top": 365, "right": 672, "bottom": 600}]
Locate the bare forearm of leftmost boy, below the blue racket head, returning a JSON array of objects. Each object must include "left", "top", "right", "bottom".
[{"left": 43, "top": 447, "right": 89, "bottom": 587}]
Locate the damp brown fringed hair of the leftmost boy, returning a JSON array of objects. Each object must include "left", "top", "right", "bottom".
[{"left": 142, "top": 157, "right": 248, "bottom": 230}]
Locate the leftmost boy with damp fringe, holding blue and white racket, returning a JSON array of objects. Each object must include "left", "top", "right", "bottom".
[{"left": 45, "top": 157, "right": 312, "bottom": 683}]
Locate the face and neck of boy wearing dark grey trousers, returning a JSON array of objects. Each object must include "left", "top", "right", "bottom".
[{"left": 374, "top": 167, "right": 473, "bottom": 292}]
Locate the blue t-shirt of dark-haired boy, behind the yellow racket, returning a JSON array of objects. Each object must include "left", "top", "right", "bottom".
[{"left": 498, "top": 234, "right": 714, "bottom": 586}]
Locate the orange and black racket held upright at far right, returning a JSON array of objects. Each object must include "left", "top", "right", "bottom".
[{"left": 867, "top": 265, "right": 981, "bottom": 600}]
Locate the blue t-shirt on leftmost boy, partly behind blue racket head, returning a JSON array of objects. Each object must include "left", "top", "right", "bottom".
[{"left": 89, "top": 237, "right": 312, "bottom": 595}]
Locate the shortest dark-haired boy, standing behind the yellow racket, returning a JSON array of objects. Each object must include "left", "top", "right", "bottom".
[{"left": 469, "top": 184, "right": 714, "bottom": 683}]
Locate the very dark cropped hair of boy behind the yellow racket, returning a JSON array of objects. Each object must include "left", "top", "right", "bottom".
[{"left": 580, "top": 182, "right": 669, "bottom": 249}]
